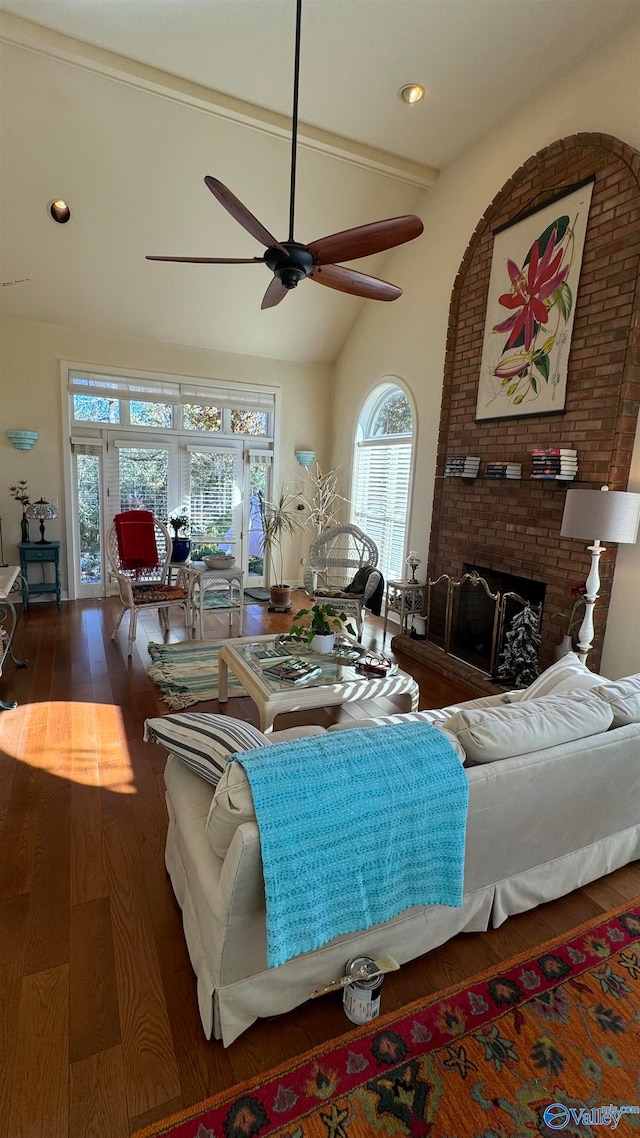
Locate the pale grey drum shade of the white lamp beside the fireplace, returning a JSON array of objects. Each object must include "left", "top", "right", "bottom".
[{"left": 560, "top": 490, "right": 640, "bottom": 545}]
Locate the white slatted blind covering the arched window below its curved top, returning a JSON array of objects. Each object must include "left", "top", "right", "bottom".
[{"left": 352, "top": 442, "right": 411, "bottom": 580}]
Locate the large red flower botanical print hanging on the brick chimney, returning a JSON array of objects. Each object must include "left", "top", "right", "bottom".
[{"left": 476, "top": 178, "right": 594, "bottom": 420}]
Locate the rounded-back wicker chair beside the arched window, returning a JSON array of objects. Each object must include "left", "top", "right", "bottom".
[{"left": 304, "top": 526, "right": 383, "bottom": 640}]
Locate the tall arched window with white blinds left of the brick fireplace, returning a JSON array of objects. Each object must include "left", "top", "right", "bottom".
[{"left": 351, "top": 381, "right": 413, "bottom": 580}]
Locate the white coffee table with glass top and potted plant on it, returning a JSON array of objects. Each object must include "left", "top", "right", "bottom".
[{"left": 218, "top": 636, "right": 419, "bottom": 733}]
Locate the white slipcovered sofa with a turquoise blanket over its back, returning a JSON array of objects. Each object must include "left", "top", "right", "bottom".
[{"left": 146, "top": 657, "right": 640, "bottom": 1046}]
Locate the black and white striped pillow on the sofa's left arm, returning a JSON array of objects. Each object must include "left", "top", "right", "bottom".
[{"left": 145, "top": 711, "right": 270, "bottom": 786}]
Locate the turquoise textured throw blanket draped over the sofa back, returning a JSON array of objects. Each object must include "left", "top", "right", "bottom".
[{"left": 233, "top": 723, "right": 469, "bottom": 967}]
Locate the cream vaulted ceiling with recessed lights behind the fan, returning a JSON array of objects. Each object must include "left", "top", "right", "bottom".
[{"left": 0, "top": 0, "right": 640, "bottom": 362}]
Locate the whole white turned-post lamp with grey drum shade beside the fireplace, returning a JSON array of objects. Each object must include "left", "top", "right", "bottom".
[{"left": 560, "top": 486, "right": 640, "bottom": 661}]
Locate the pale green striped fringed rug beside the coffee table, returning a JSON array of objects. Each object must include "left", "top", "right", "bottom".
[{"left": 148, "top": 641, "right": 247, "bottom": 711}]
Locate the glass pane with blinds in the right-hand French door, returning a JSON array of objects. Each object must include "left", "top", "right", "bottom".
[{"left": 189, "top": 451, "right": 237, "bottom": 558}]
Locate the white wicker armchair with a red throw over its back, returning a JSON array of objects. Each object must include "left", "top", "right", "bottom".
[{"left": 107, "top": 511, "right": 198, "bottom": 655}]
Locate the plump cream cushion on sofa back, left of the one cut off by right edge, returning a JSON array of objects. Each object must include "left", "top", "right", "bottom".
[{"left": 446, "top": 691, "right": 613, "bottom": 762}]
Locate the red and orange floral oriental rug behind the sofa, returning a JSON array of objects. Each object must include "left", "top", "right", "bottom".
[{"left": 137, "top": 902, "right": 640, "bottom": 1138}]
